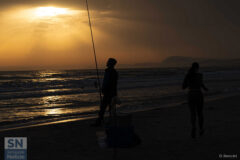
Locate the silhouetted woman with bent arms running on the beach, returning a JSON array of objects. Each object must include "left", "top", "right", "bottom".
[{"left": 182, "top": 62, "right": 208, "bottom": 138}]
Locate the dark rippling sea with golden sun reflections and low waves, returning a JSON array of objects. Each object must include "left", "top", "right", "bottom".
[{"left": 0, "top": 67, "right": 240, "bottom": 130}]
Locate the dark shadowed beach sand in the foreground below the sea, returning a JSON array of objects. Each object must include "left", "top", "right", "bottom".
[{"left": 0, "top": 96, "right": 240, "bottom": 160}]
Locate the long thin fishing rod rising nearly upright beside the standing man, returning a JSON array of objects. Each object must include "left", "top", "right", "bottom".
[{"left": 86, "top": 0, "right": 102, "bottom": 103}]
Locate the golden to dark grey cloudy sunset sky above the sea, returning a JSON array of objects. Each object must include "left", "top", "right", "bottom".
[{"left": 0, "top": 0, "right": 240, "bottom": 70}]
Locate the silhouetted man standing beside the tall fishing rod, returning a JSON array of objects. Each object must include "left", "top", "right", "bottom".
[{"left": 95, "top": 58, "right": 118, "bottom": 126}]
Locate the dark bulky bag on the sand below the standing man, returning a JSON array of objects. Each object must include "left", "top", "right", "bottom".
[{"left": 106, "top": 115, "right": 141, "bottom": 148}]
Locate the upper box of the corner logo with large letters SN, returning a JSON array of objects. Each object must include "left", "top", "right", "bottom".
[{"left": 4, "top": 137, "right": 27, "bottom": 149}]
